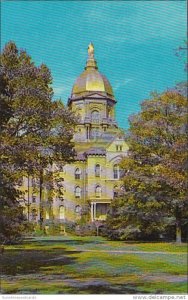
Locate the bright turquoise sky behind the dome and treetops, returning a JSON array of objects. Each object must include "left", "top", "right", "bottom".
[{"left": 1, "top": 0, "right": 187, "bottom": 128}]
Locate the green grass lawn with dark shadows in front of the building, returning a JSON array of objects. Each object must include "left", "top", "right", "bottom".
[{"left": 1, "top": 236, "right": 187, "bottom": 294}]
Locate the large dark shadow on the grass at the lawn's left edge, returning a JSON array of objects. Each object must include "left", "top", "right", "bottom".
[{"left": 1, "top": 248, "right": 79, "bottom": 276}]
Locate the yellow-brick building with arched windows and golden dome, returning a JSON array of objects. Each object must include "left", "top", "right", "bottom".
[{"left": 18, "top": 43, "right": 128, "bottom": 232}]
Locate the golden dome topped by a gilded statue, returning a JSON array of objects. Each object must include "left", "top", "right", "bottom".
[{"left": 71, "top": 43, "right": 114, "bottom": 99}]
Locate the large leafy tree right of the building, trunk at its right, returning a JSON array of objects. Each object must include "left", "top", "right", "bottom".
[{"left": 107, "top": 91, "right": 187, "bottom": 242}]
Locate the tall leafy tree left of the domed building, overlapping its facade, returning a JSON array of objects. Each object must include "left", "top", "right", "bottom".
[{"left": 0, "top": 42, "right": 75, "bottom": 244}]
